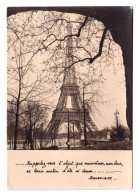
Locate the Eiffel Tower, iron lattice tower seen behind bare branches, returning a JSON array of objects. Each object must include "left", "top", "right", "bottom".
[{"left": 46, "top": 23, "right": 98, "bottom": 145}]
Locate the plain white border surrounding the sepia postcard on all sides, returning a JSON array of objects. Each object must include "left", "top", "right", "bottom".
[{"left": 0, "top": 0, "right": 139, "bottom": 196}]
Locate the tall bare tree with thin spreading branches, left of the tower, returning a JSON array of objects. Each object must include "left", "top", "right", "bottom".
[{"left": 7, "top": 13, "right": 52, "bottom": 149}]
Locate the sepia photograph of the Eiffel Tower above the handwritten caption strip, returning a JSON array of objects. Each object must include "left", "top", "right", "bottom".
[{"left": 7, "top": 6, "right": 133, "bottom": 150}]
